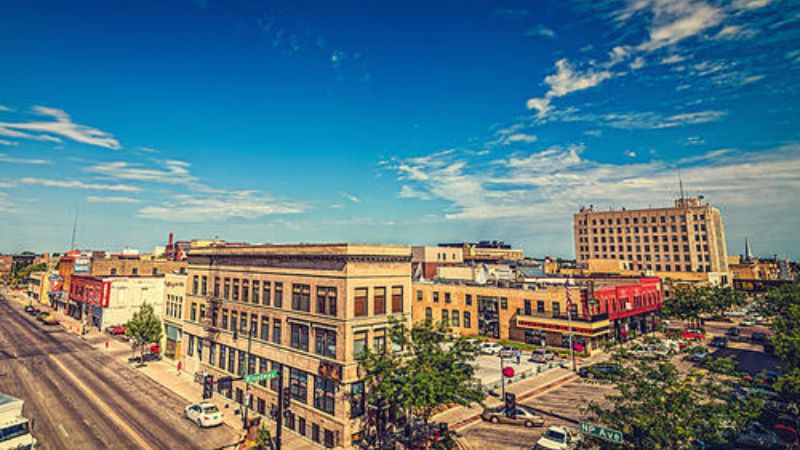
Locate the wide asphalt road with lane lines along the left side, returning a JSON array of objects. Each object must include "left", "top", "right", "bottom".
[{"left": 0, "top": 295, "right": 236, "bottom": 450}]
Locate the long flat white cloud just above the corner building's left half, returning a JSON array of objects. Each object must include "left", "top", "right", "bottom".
[{"left": 138, "top": 191, "right": 305, "bottom": 222}]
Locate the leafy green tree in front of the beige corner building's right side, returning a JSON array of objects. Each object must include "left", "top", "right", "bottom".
[{"left": 359, "top": 321, "right": 485, "bottom": 446}]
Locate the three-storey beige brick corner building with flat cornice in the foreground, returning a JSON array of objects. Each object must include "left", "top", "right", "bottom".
[{"left": 183, "top": 244, "right": 411, "bottom": 448}]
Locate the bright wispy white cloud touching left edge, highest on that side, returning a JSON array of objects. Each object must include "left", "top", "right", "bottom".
[{"left": 0, "top": 106, "right": 122, "bottom": 150}]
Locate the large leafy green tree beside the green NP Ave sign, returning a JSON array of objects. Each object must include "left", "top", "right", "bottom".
[{"left": 587, "top": 361, "right": 761, "bottom": 450}]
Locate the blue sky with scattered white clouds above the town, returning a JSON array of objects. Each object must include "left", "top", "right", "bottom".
[{"left": 0, "top": 0, "right": 800, "bottom": 258}]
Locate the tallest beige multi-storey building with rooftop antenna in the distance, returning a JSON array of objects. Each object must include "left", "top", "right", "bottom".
[{"left": 574, "top": 197, "right": 729, "bottom": 283}]
